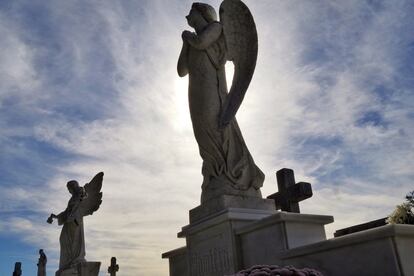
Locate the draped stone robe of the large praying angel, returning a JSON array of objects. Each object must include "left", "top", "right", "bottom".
[{"left": 187, "top": 22, "right": 264, "bottom": 202}]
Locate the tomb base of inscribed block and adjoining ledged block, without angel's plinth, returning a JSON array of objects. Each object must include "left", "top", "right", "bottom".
[{"left": 162, "top": 204, "right": 333, "bottom": 276}]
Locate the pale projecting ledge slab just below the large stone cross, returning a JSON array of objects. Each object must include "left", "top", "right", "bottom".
[{"left": 236, "top": 211, "right": 334, "bottom": 235}]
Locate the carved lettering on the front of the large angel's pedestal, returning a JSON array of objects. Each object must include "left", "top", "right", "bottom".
[{"left": 190, "top": 248, "right": 230, "bottom": 276}]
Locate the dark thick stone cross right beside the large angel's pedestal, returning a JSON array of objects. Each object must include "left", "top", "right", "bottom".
[{"left": 267, "top": 168, "right": 312, "bottom": 213}]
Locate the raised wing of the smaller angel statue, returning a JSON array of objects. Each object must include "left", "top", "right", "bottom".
[{"left": 80, "top": 172, "right": 103, "bottom": 216}]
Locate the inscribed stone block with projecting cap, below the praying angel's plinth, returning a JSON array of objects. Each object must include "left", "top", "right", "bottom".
[{"left": 178, "top": 208, "right": 275, "bottom": 276}]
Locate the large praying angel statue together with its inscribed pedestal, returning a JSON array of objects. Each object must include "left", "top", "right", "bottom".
[{"left": 163, "top": 0, "right": 282, "bottom": 276}]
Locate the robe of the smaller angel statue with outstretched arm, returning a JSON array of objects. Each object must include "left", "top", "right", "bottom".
[{"left": 57, "top": 195, "right": 86, "bottom": 270}]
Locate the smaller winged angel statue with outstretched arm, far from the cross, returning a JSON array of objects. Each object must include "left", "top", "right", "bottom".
[{"left": 47, "top": 172, "right": 104, "bottom": 275}]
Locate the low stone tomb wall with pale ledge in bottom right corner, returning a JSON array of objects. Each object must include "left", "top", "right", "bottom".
[{"left": 277, "top": 225, "right": 414, "bottom": 276}]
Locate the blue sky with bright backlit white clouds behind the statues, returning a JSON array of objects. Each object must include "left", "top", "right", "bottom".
[{"left": 0, "top": 0, "right": 414, "bottom": 276}]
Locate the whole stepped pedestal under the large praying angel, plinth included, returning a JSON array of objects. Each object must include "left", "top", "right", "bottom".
[{"left": 162, "top": 195, "right": 276, "bottom": 276}]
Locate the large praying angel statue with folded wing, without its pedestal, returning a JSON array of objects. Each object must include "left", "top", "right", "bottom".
[{"left": 177, "top": 0, "right": 264, "bottom": 203}]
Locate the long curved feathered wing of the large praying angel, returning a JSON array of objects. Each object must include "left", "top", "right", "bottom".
[{"left": 219, "top": 0, "right": 258, "bottom": 126}]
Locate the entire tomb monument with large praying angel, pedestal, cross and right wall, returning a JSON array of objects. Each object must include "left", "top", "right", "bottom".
[{"left": 162, "top": 0, "right": 414, "bottom": 276}]
